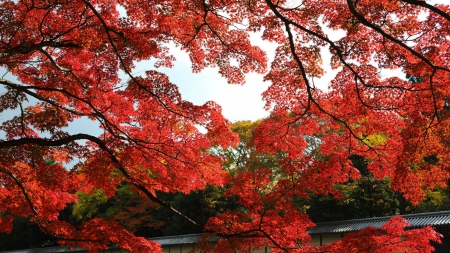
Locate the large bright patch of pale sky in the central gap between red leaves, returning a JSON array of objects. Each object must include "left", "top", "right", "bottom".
[{"left": 133, "top": 35, "right": 276, "bottom": 122}]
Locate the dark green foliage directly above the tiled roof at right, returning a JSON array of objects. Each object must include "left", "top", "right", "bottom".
[{"left": 296, "top": 152, "right": 450, "bottom": 222}]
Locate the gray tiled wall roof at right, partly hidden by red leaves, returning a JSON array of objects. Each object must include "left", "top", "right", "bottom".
[{"left": 308, "top": 211, "right": 450, "bottom": 235}]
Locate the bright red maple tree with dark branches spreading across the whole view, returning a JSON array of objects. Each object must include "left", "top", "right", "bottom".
[{"left": 0, "top": 0, "right": 450, "bottom": 252}]
